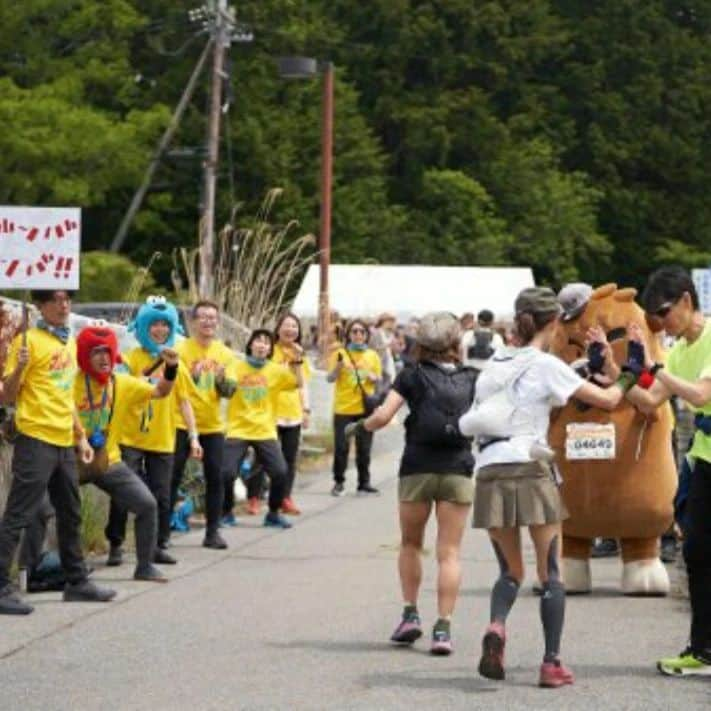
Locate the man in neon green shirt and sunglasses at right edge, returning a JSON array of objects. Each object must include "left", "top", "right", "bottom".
[{"left": 628, "top": 267, "right": 711, "bottom": 676}]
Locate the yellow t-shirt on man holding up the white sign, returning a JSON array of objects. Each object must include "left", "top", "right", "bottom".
[{"left": 5, "top": 328, "right": 77, "bottom": 447}]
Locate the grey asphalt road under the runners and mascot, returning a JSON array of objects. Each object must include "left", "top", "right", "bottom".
[{"left": 0, "top": 428, "right": 711, "bottom": 711}]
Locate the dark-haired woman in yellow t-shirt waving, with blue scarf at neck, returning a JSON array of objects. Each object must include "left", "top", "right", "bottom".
[{"left": 223, "top": 329, "right": 303, "bottom": 528}]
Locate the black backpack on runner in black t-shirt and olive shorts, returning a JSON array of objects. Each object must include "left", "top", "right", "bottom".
[{"left": 405, "top": 365, "right": 476, "bottom": 448}]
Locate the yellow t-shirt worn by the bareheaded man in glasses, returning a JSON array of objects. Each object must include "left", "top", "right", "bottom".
[{"left": 175, "top": 338, "right": 237, "bottom": 434}]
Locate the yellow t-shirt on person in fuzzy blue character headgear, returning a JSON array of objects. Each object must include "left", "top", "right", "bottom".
[{"left": 121, "top": 348, "right": 190, "bottom": 454}]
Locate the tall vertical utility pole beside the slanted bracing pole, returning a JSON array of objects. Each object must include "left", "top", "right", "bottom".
[{"left": 199, "top": 0, "right": 227, "bottom": 299}]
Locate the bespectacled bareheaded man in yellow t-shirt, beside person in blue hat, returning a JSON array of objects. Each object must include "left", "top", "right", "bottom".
[{"left": 170, "top": 301, "right": 237, "bottom": 549}]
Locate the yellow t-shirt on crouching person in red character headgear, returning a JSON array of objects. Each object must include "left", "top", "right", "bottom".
[{"left": 74, "top": 373, "right": 154, "bottom": 466}]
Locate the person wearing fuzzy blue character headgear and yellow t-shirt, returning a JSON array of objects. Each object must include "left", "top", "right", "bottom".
[{"left": 106, "top": 296, "right": 202, "bottom": 566}]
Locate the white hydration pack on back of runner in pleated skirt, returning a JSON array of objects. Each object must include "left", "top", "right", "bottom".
[{"left": 459, "top": 349, "right": 537, "bottom": 439}]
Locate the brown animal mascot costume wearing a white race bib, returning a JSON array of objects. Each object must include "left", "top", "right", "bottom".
[{"left": 550, "top": 284, "right": 677, "bottom": 595}]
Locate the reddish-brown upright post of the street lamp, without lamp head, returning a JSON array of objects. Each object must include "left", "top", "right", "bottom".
[{"left": 318, "top": 62, "right": 333, "bottom": 364}]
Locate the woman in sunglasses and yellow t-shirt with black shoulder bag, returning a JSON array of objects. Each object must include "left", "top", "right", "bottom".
[{"left": 328, "top": 319, "right": 382, "bottom": 496}]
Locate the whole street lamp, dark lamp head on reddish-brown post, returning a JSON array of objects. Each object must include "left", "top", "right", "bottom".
[{"left": 277, "top": 57, "right": 333, "bottom": 364}]
